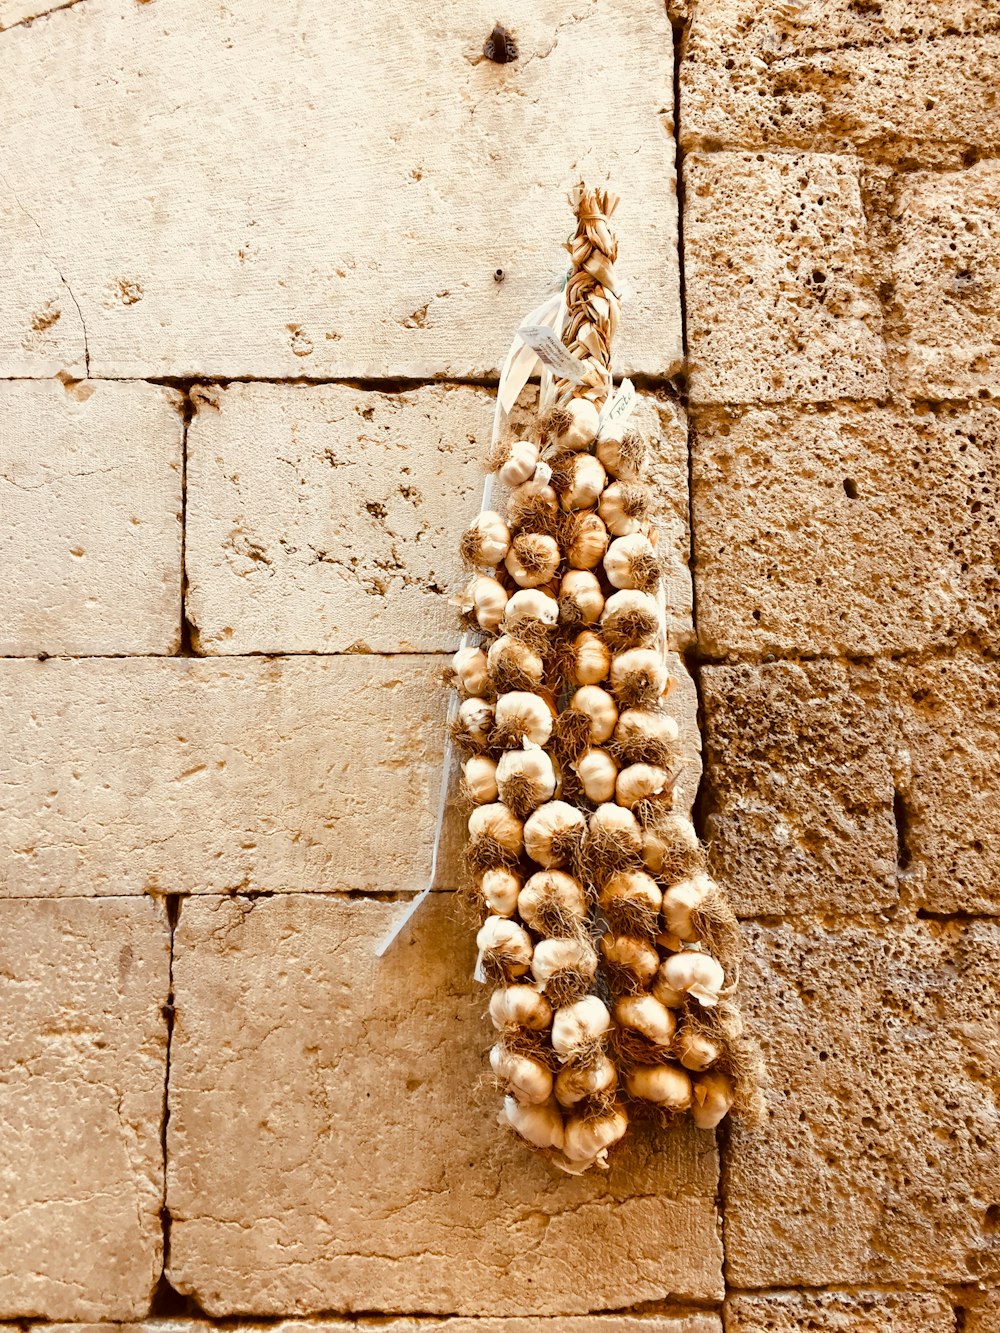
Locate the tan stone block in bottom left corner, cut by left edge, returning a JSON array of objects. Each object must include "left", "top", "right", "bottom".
[{"left": 0, "top": 898, "right": 169, "bottom": 1321}]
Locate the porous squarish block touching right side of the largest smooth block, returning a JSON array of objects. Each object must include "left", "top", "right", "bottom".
[{"left": 684, "top": 153, "right": 887, "bottom": 403}]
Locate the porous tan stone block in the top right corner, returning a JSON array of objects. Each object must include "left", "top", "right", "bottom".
[{"left": 680, "top": 0, "right": 1000, "bottom": 167}]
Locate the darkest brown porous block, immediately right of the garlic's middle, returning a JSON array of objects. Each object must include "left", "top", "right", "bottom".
[{"left": 701, "top": 663, "right": 904, "bottom": 916}]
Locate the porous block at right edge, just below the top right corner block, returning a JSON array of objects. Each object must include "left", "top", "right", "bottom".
[{"left": 887, "top": 161, "right": 1000, "bottom": 399}]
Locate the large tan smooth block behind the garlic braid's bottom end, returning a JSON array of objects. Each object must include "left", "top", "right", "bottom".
[{"left": 168, "top": 894, "right": 721, "bottom": 1316}]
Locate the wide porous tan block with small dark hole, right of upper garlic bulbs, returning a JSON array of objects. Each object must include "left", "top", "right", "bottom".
[{"left": 692, "top": 403, "right": 1000, "bottom": 656}]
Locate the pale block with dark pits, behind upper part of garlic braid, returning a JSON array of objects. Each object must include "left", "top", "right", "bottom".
[{"left": 185, "top": 384, "right": 692, "bottom": 653}]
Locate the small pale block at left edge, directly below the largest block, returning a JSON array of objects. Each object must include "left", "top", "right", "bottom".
[{"left": 0, "top": 380, "right": 183, "bottom": 656}]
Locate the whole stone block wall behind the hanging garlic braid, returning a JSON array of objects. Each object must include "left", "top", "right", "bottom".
[{"left": 0, "top": 0, "right": 1000, "bottom": 1333}]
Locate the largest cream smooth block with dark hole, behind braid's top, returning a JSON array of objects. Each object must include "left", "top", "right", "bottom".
[{"left": 0, "top": 0, "right": 683, "bottom": 380}]
